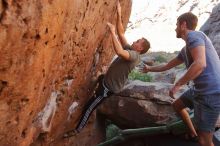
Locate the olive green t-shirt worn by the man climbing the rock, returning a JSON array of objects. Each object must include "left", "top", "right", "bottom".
[{"left": 104, "top": 45, "right": 140, "bottom": 93}]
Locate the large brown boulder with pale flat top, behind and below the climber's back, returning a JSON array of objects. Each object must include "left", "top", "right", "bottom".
[{"left": 99, "top": 80, "right": 188, "bottom": 128}]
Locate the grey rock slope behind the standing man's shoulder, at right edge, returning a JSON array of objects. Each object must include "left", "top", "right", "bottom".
[{"left": 200, "top": 3, "right": 220, "bottom": 56}]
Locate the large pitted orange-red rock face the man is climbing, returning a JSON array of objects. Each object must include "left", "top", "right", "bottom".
[{"left": 0, "top": 0, "right": 131, "bottom": 146}]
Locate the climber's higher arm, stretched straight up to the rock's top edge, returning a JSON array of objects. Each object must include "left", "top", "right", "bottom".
[{"left": 117, "top": 1, "right": 128, "bottom": 47}]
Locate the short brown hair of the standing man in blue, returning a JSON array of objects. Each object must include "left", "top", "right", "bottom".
[{"left": 177, "top": 12, "right": 198, "bottom": 30}]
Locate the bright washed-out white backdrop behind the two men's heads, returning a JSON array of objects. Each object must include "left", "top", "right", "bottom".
[{"left": 125, "top": 0, "right": 218, "bottom": 52}]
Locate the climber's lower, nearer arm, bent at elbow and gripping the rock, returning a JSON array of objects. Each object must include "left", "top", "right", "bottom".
[{"left": 107, "top": 22, "right": 130, "bottom": 60}]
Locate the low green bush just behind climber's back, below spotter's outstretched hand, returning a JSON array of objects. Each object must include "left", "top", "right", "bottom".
[{"left": 128, "top": 70, "right": 153, "bottom": 82}]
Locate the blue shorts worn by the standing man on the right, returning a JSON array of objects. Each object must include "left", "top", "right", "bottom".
[{"left": 180, "top": 89, "right": 220, "bottom": 132}]
